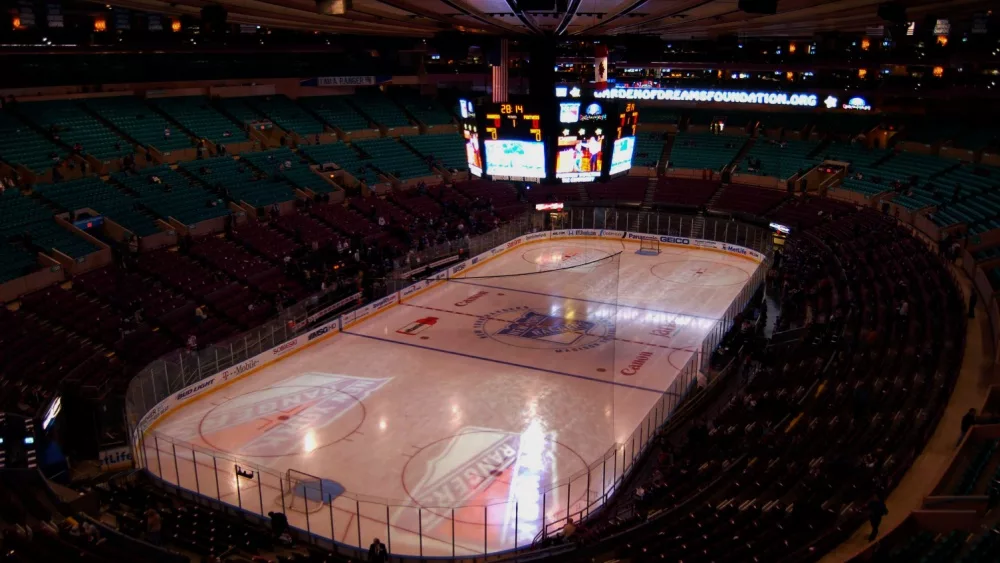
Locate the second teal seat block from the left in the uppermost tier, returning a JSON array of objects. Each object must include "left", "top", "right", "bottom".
[{"left": 19, "top": 100, "right": 134, "bottom": 161}]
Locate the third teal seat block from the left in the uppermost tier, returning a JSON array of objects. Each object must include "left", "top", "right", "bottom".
[{"left": 86, "top": 96, "right": 192, "bottom": 153}]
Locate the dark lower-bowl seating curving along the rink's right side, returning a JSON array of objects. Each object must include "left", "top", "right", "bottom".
[{"left": 556, "top": 207, "right": 964, "bottom": 562}]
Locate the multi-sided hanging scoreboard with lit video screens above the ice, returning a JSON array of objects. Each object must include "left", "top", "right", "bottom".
[{"left": 459, "top": 97, "right": 639, "bottom": 183}]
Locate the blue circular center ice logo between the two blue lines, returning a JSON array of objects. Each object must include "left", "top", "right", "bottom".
[{"left": 473, "top": 307, "right": 615, "bottom": 352}]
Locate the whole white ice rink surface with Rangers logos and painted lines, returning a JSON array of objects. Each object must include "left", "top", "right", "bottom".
[{"left": 144, "top": 239, "right": 758, "bottom": 555}]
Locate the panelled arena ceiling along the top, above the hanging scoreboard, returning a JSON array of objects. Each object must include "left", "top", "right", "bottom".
[{"left": 101, "top": 0, "right": 992, "bottom": 39}]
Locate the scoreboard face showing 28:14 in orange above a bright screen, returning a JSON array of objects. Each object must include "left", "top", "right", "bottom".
[{"left": 481, "top": 103, "right": 548, "bottom": 181}]
